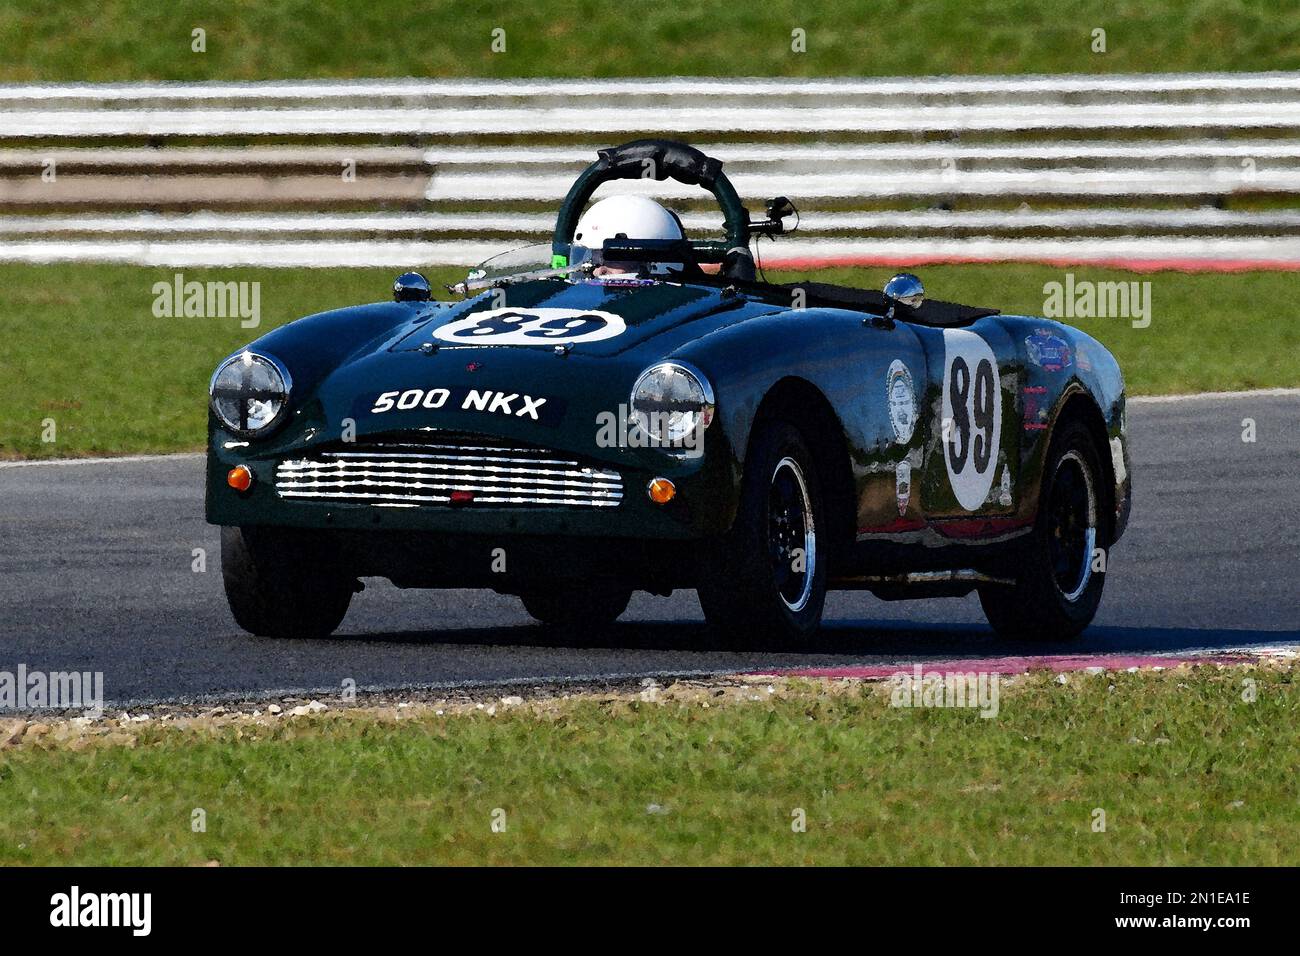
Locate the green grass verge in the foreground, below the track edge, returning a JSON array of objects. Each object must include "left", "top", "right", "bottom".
[{"left": 0, "top": 666, "right": 1300, "bottom": 865}]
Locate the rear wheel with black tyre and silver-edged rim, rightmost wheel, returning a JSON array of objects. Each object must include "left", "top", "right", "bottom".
[{"left": 979, "top": 423, "right": 1110, "bottom": 640}]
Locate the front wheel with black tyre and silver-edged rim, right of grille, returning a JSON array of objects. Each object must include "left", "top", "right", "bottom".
[{"left": 698, "top": 419, "right": 826, "bottom": 646}]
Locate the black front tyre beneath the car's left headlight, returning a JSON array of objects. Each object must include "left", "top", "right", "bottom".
[{"left": 221, "top": 528, "right": 358, "bottom": 637}]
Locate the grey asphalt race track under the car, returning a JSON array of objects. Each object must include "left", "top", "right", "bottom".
[{"left": 0, "top": 393, "right": 1300, "bottom": 705}]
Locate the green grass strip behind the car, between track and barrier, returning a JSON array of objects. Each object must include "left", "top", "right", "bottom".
[{"left": 0, "top": 264, "right": 1300, "bottom": 458}]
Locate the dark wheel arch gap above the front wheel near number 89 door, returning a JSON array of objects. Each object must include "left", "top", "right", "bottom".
[{"left": 745, "top": 376, "right": 857, "bottom": 562}]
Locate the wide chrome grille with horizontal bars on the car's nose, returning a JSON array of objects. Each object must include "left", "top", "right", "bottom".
[{"left": 276, "top": 442, "right": 623, "bottom": 507}]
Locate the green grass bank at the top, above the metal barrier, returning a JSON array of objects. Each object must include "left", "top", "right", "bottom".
[{"left": 0, "top": 0, "right": 1300, "bottom": 82}]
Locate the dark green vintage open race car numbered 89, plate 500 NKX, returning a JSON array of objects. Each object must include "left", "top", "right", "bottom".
[{"left": 207, "top": 140, "right": 1130, "bottom": 644}]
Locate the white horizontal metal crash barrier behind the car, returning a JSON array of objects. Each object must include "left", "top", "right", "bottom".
[{"left": 0, "top": 73, "right": 1300, "bottom": 269}]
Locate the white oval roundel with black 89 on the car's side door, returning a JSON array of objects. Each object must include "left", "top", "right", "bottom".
[{"left": 943, "top": 329, "right": 1002, "bottom": 511}]
